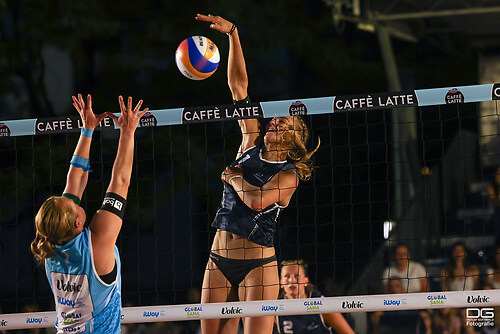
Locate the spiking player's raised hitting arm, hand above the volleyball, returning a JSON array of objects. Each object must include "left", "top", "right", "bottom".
[{"left": 196, "top": 14, "right": 261, "bottom": 158}]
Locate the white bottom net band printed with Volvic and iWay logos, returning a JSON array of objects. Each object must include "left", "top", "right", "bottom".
[{"left": 0, "top": 290, "right": 500, "bottom": 330}]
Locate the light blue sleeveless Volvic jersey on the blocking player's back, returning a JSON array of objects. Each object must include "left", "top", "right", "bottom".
[{"left": 45, "top": 228, "right": 121, "bottom": 333}]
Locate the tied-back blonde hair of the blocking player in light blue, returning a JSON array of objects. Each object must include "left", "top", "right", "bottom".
[{"left": 31, "top": 196, "right": 77, "bottom": 262}]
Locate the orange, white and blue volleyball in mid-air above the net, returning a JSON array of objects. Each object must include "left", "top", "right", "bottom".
[{"left": 175, "top": 36, "right": 220, "bottom": 80}]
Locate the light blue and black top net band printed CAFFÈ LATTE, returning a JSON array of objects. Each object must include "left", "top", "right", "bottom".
[{"left": 0, "top": 84, "right": 500, "bottom": 137}]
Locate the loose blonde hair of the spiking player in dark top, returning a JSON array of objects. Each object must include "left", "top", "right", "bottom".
[{"left": 287, "top": 116, "right": 321, "bottom": 181}]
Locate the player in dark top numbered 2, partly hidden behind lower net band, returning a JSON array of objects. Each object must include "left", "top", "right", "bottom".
[{"left": 276, "top": 260, "right": 354, "bottom": 334}]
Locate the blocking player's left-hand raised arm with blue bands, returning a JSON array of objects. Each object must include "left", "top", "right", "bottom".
[{"left": 64, "top": 94, "right": 107, "bottom": 199}]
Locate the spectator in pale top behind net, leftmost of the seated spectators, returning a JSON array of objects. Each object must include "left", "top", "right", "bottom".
[{"left": 382, "top": 243, "right": 429, "bottom": 293}]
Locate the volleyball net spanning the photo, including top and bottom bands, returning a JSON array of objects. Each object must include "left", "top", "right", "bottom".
[{"left": 0, "top": 84, "right": 500, "bottom": 332}]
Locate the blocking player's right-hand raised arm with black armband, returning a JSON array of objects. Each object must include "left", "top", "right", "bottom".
[{"left": 90, "top": 96, "right": 148, "bottom": 275}]
